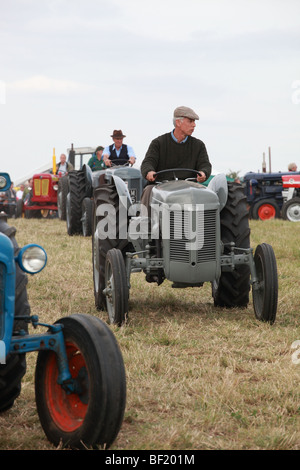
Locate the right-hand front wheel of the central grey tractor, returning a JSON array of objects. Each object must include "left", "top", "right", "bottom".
[{"left": 252, "top": 243, "right": 278, "bottom": 324}]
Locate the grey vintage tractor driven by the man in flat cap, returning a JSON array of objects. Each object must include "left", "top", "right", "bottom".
[{"left": 93, "top": 169, "right": 278, "bottom": 325}]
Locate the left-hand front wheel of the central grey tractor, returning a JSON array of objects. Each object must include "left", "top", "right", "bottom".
[{"left": 104, "top": 248, "right": 129, "bottom": 326}]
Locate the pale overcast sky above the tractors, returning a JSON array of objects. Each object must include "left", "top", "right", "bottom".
[{"left": 0, "top": 0, "right": 300, "bottom": 182}]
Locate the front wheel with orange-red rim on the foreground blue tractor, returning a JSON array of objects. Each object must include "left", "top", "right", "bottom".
[{"left": 35, "top": 314, "right": 126, "bottom": 449}]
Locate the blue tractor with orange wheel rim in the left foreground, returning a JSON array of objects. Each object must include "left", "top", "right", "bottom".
[{"left": 0, "top": 173, "right": 126, "bottom": 449}]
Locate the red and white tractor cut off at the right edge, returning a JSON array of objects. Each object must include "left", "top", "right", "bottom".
[{"left": 282, "top": 173, "right": 300, "bottom": 222}]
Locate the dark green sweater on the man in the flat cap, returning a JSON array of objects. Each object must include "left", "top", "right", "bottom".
[{"left": 141, "top": 132, "right": 211, "bottom": 181}]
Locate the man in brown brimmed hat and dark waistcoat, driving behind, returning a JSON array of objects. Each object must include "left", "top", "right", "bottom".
[{"left": 103, "top": 130, "right": 136, "bottom": 166}]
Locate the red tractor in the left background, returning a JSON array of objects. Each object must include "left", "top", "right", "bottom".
[{"left": 23, "top": 173, "right": 59, "bottom": 218}]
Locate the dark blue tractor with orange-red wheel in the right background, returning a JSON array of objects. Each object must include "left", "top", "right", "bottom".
[{"left": 243, "top": 172, "right": 298, "bottom": 220}]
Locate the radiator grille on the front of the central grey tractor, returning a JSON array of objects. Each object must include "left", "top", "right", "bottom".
[{"left": 170, "top": 210, "right": 217, "bottom": 263}]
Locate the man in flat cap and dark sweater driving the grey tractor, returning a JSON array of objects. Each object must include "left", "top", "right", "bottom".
[{"left": 141, "top": 106, "right": 211, "bottom": 183}]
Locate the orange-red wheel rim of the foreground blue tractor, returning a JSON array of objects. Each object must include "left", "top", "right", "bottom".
[{"left": 45, "top": 342, "right": 89, "bottom": 432}]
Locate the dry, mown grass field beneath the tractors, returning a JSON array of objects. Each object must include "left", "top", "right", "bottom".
[{"left": 0, "top": 215, "right": 300, "bottom": 450}]
